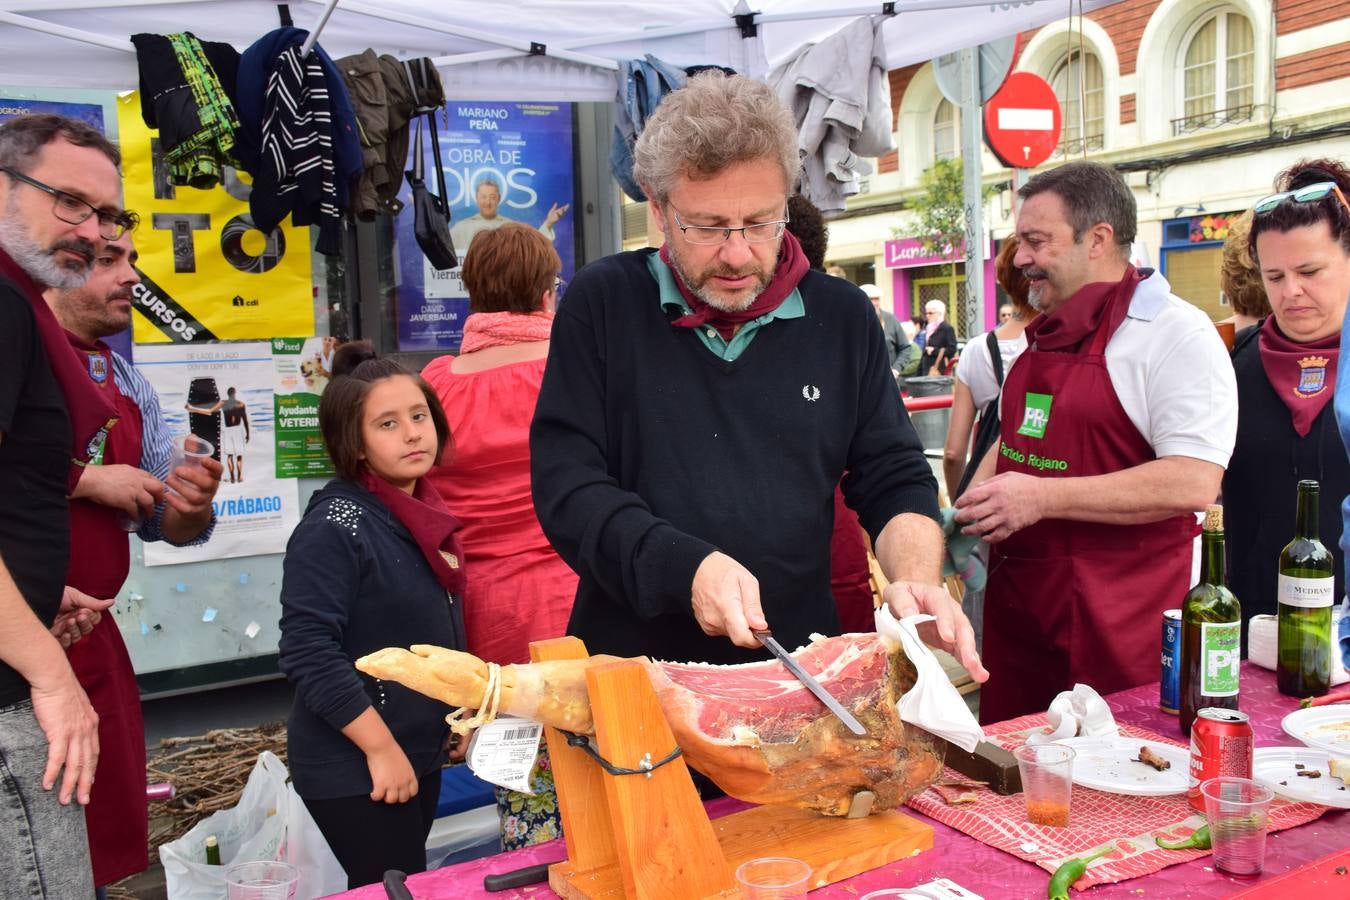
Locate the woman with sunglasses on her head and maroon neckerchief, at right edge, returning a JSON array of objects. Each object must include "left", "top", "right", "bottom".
[{"left": 1223, "top": 159, "right": 1350, "bottom": 637}]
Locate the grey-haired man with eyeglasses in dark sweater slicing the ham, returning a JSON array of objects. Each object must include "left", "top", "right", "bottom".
[{"left": 531, "top": 72, "right": 986, "bottom": 680}]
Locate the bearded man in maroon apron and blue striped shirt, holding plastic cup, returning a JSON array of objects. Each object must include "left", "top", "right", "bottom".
[{"left": 46, "top": 231, "right": 221, "bottom": 887}]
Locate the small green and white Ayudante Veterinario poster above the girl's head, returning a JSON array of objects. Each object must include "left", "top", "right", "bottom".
[{"left": 271, "top": 337, "right": 338, "bottom": 478}]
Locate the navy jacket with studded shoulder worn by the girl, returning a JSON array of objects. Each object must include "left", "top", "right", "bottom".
[{"left": 279, "top": 479, "right": 464, "bottom": 800}]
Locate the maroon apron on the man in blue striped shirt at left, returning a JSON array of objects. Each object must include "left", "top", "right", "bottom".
[{"left": 66, "top": 337, "right": 150, "bottom": 885}]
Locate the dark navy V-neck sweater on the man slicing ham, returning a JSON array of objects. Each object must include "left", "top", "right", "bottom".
[{"left": 531, "top": 251, "right": 937, "bottom": 663}]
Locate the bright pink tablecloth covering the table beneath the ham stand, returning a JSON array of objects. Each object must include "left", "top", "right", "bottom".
[{"left": 332, "top": 663, "right": 1350, "bottom": 900}]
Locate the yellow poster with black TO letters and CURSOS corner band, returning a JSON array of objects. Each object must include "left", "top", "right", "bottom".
[{"left": 117, "top": 92, "right": 315, "bottom": 344}]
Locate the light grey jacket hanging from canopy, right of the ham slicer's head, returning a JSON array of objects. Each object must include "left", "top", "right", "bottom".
[{"left": 768, "top": 16, "right": 895, "bottom": 215}]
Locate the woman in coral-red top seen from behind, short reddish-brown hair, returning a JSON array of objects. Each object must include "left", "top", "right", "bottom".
[{"left": 423, "top": 224, "right": 576, "bottom": 850}]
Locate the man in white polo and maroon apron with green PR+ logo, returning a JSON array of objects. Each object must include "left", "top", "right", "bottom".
[{"left": 956, "top": 162, "right": 1238, "bottom": 722}]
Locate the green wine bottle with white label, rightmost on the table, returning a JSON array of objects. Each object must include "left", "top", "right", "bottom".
[{"left": 1276, "top": 480, "right": 1335, "bottom": 698}]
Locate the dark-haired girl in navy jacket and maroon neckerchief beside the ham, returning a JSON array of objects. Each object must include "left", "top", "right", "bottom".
[{"left": 279, "top": 344, "right": 464, "bottom": 888}]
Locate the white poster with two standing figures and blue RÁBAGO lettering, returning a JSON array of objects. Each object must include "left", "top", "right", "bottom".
[{"left": 136, "top": 341, "right": 300, "bottom": 565}]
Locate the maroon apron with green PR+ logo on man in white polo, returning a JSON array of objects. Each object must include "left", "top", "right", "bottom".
[{"left": 980, "top": 288, "right": 1199, "bottom": 723}]
